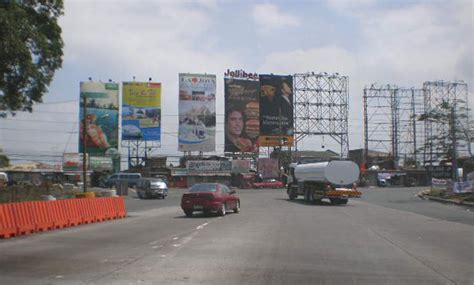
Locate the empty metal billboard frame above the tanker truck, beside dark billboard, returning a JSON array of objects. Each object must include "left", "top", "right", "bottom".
[{"left": 293, "top": 72, "right": 349, "bottom": 157}]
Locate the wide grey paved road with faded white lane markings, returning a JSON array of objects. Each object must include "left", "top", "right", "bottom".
[{"left": 0, "top": 189, "right": 474, "bottom": 285}]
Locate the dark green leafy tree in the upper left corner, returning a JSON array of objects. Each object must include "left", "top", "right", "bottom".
[{"left": 0, "top": 0, "right": 64, "bottom": 116}]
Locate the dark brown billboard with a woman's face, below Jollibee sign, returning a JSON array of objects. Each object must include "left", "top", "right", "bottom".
[{"left": 224, "top": 78, "right": 260, "bottom": 152}]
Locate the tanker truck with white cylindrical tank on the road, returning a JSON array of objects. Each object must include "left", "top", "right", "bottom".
[{"left": 287, "top": 160, "right": 361, "bottom": 204}]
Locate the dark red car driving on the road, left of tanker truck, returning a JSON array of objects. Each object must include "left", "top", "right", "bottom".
[{"left": 181, "top": 183, "right": 240, "bottom": 217}]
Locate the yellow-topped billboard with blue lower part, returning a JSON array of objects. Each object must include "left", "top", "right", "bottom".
[{"left": 122, "top": 82, "right": 161, "bottom": 141}]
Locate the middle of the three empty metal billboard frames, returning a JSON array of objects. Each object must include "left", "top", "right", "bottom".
[{"left": 363, "top": 84, "right": 424, "bottom": 166}]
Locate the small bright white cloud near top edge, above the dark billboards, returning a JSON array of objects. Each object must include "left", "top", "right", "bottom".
[{"left": 252, "top": 4, "right": 300, "bottom": 32}]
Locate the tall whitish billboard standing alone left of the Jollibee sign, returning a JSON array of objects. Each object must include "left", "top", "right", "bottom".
[{"left": 178, "top": 73, "right": 216, "bottom": 152}]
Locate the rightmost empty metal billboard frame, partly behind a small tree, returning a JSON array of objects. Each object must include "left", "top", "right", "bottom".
[{"left": 423, "top": 81, "right": 471, "bottom": 166}]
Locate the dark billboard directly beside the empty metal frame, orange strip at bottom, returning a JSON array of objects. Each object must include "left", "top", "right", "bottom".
[{"left": 259, "top": 75, "right": 293, "bottom": 146}]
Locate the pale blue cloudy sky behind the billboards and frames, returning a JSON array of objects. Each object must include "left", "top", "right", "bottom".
[{"left": 0, "top": 0, "right": 474, "bottom": 165}]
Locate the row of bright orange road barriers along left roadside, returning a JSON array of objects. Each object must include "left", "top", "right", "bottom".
[{"left": 0, "top": 197, "right": 127, "bottom": 238}]
